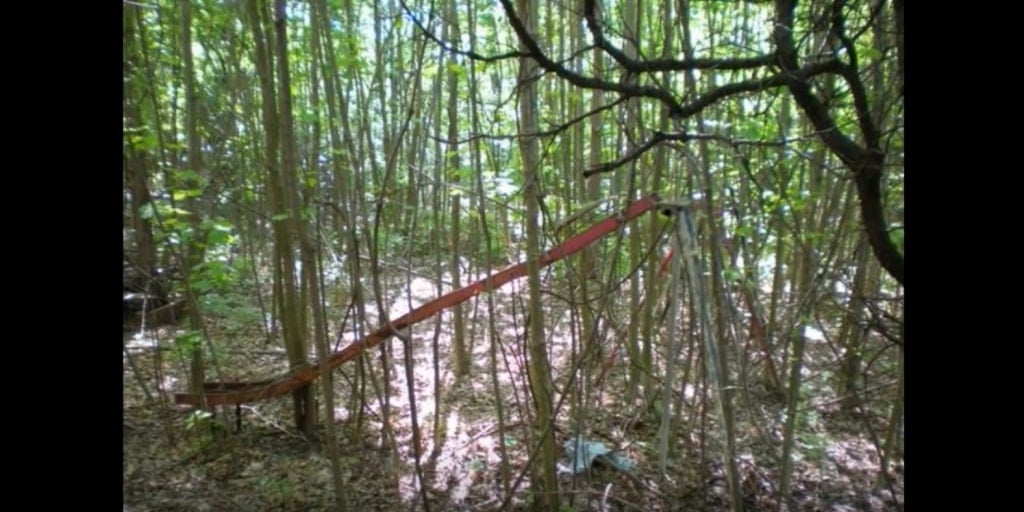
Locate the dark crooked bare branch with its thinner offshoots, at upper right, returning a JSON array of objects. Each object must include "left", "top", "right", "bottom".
[{"left": 401, "top": 0, "right": 904, "bottom": 285}]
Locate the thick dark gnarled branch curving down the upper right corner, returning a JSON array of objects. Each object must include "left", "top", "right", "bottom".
[{"left": 491, "top": 0, "right": 904, "bottom": 285}]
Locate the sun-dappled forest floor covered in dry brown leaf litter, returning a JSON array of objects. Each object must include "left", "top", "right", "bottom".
[{"left": 123, "top": 270, "right": 903, "bottom": 512}]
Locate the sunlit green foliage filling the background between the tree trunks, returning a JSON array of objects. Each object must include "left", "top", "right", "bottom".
[{"left": 123, "top": 0, "right": 904, "bottom": 506}]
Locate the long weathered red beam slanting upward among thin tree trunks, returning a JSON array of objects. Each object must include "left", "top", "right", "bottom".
[{"left": 174, "top": 196, "right": 657, "bottom": 406}]
